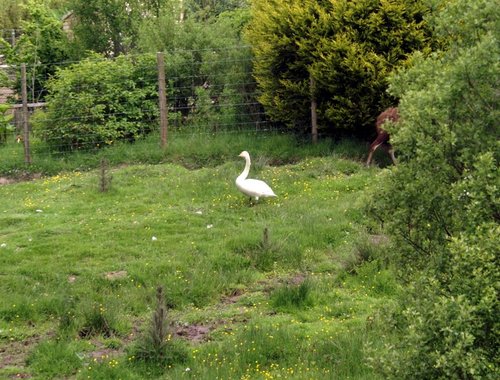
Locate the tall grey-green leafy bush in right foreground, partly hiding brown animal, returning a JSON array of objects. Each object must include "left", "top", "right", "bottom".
[{"left": 371, "top": 0, "right": 500, "bottom": 379}]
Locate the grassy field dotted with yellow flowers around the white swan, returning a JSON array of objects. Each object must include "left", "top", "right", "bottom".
[{"left": 0, "top": 135, "right": 397, "bottom": 379}]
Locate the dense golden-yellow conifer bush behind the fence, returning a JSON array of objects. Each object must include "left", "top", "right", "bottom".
[{"left": 247, "top": 0, "right": 432, "bottom": 136}]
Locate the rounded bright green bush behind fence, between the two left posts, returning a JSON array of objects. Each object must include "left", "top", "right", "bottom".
[{"left": 32, "top": 56, "right": 158, "bottom": 151}]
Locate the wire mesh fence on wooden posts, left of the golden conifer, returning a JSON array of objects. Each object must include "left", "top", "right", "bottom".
[{"left": 0, "top": 46, "right": 286, "bottom": 163}]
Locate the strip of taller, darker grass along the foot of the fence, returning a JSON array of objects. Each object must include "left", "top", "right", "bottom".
[{"left": 0, "top": 130, "right": 372, "bottom": 177}]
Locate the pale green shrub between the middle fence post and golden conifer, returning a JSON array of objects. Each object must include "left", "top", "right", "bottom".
[{"left": 139, "top": 5, "right": 261, "bottom": 131}]
